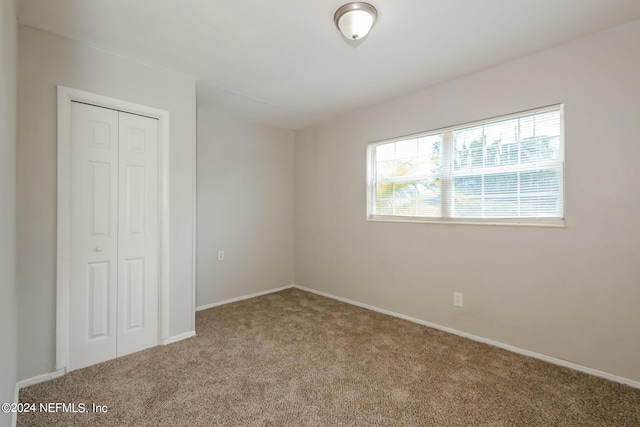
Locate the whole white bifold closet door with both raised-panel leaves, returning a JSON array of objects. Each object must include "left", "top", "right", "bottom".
[{"left": 69, "top": 102, "right": 159, "bottom": 370}]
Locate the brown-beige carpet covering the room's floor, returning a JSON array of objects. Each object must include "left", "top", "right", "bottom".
[{"left": 18, "top": 289, "right": 640, "bottom": 426}]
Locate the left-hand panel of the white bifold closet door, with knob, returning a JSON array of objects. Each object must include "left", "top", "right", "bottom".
[{"left": 69, "top": 102, "right": 118, "bottom": 370}]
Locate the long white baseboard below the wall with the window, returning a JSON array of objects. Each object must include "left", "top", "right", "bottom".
[{"left": 293, "top": 285, "right": 640, "bottom": 389}]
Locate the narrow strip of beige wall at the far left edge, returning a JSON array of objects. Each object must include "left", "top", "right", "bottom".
[{"left": 0, "top": 0, "right": 18, "bottom": 425}]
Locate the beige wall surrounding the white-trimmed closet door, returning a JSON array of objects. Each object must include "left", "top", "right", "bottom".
[{"left": 17, "top": 27, "right": 195, "bottom": 379}]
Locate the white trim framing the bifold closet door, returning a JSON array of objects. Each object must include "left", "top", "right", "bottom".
[{"left": 56, "top": 86, "right": 170, "bottom": 371}]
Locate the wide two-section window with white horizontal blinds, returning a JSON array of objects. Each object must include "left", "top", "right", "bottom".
[{"left": 367, "top": 105, "right": 564, "bottom": 226}]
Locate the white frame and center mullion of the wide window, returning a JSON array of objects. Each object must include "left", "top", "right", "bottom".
[{"left": 366, "top": 104, "right": 566, "bottom": 227}]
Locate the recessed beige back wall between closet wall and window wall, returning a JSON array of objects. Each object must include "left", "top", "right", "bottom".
[{"left": 196, "top": 108, "right": 293, "bottom": 306}]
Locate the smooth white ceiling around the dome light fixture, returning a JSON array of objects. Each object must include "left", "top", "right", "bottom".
[{"left": 19, "top": 0, "right": 640, "bottom": 129}]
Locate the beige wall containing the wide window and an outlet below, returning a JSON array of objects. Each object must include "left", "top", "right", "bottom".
[{"left": 294, "top": 21, "right": 640, "bottom": 381}]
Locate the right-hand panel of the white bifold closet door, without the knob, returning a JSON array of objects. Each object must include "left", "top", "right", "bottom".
[{"left": 118, "top": 112, "right": 160, "bottom": 356}]
